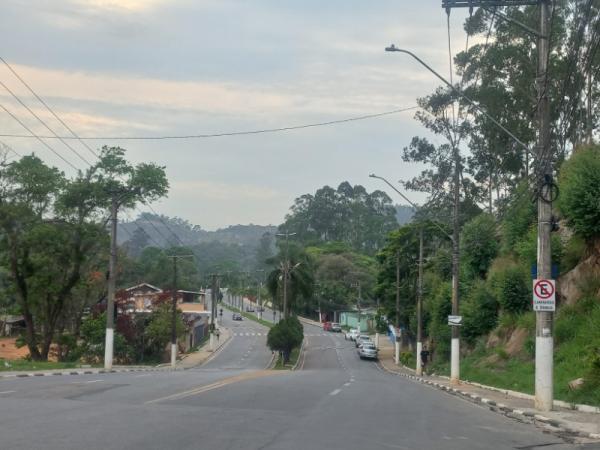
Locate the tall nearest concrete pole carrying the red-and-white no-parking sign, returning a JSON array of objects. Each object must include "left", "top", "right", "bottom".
[{"left": 535, "top": 0, "right": 554, "bottom": 411}]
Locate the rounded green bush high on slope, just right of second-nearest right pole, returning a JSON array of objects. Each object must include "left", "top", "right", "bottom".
[{"left": 461, "top": 214, "right": 498, "bottom": 278}]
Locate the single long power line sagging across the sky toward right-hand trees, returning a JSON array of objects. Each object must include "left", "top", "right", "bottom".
[{"left": 0, "top": 105, "right": 419, "bottom": 141}]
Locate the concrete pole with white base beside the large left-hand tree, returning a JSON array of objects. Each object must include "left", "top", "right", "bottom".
[{"left": 104, "top": 193, "right": 118, "bottom": 370}]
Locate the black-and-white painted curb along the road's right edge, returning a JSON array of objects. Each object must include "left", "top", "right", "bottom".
[{"left": 378, "top": 362, "right": 600, "bottom": 440}]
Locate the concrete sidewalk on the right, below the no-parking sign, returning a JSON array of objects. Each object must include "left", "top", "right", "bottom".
[{"left": 379, "top": 336, "right": 600, "bottom": 442}]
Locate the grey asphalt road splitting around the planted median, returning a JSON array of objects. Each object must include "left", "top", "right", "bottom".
[{"left": 0, "top": 313, "right": 600, "bottom": 450}]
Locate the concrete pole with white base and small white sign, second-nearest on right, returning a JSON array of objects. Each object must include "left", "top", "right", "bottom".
[{"left": 450, "top": 143, "right": 460, "bottom": 384}]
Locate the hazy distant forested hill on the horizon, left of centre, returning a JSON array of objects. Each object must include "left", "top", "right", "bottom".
[{"left": 118, "top": 213, "right": 277, "bottom": 250}]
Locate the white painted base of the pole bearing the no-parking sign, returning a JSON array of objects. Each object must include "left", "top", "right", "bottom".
[{"left": 535, "top": 336, "right": 554, "bottom": 411}]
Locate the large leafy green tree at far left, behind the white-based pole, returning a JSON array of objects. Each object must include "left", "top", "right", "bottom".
[{"left": 0, "top": 147, "right": 168, "bottom": 360}]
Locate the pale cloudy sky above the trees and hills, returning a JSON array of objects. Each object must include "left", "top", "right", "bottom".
[{"left": 0, "top": 0, "right": 474, "bottom": 230}]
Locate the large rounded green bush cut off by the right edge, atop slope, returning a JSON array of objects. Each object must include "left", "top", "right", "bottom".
[{"left": 558, "top": 146, "right": 600, "bottom": 240}]
